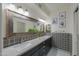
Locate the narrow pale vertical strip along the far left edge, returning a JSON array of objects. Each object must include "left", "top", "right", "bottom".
[{"left": 0, "top": 3, "right": 2, "bottom": 56}]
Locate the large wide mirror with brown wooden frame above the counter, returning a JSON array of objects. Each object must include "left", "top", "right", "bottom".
[{"left": 6, "top": 9, "right": 45, "bottom": 36}]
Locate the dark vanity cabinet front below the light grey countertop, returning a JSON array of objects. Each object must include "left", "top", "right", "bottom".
[{"left": 21, "top": 38, "right": 52, "bottom": 56}]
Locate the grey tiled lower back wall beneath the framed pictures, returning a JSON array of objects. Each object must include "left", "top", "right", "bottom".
[{"left": 52, "top": 33, "right": 72, "bottom": 52}]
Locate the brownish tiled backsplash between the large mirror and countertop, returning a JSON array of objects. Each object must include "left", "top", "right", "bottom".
[{"left": 3, "top": 33, "right": 46, "bottom": 48}]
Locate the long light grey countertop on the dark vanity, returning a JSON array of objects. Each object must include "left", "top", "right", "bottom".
[{"left": 2, "top": 35, "right": 51, "bottom": 56}]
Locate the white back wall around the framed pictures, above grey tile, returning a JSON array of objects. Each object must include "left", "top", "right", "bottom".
[{"left": 48, "top": 4, "right": 77, "bottom": 55}]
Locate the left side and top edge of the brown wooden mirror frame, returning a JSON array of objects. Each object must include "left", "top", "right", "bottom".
[{"left": 5, "top": 9, "right": 38, "bottom": 37}]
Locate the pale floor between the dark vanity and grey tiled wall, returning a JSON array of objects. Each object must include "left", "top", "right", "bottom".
[{"left": 47, "top": 48, "right": 70, "bottom": 56}]
